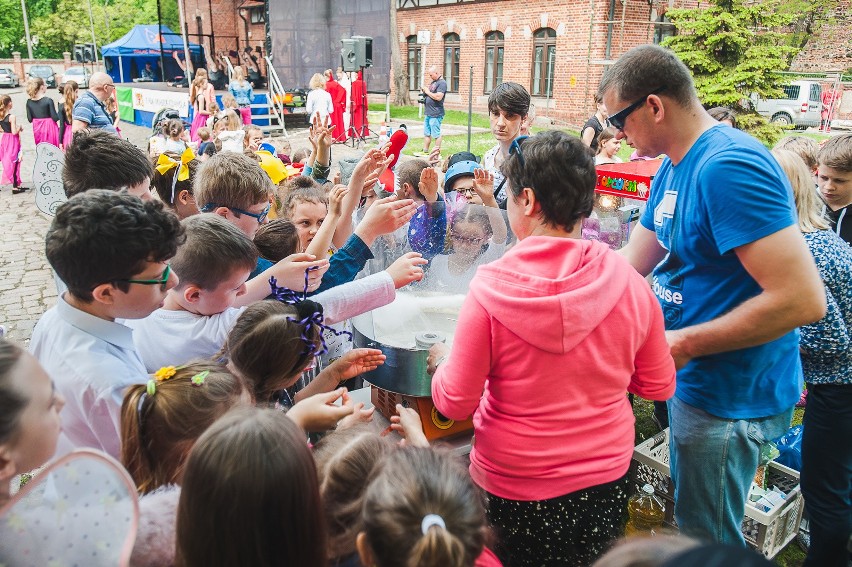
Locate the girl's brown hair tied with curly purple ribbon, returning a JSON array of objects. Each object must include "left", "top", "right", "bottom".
[{"left": 220, "top": 300, "right": 322, "bottom": 404}]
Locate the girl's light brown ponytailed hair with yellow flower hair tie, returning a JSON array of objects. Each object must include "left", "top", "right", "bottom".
[{"left": 121, "top": 361, "right": 245, "bottom": 494}]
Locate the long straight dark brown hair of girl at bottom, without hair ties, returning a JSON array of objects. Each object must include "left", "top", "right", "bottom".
[{"left": 175, "top": 407, "right": 327, "bottom": 567}]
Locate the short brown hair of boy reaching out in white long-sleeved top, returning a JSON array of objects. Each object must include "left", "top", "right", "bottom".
[{"left": 172, "top": 213, "right": 257, "bottom": 290}]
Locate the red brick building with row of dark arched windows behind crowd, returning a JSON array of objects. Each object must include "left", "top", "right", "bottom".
[{"left": 396, "top": 0, "right": 697, "bottom": 125}]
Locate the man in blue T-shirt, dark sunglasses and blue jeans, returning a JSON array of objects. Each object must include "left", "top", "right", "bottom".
[{"left": 598, "top": 45, "right": 825, "bottom": 545}]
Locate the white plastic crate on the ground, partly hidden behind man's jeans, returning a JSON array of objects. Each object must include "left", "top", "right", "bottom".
[{"left": 630, "top": 429, "right": 804, "bottom": 559}]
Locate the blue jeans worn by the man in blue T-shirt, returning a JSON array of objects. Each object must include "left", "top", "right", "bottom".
[{"left": 668, "top": 397, "right": 793, "bottom": 546}]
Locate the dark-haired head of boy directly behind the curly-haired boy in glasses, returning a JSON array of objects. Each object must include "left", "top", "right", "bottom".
[{"left": 62, "top": 129, "right": 154, "bottom": 201}]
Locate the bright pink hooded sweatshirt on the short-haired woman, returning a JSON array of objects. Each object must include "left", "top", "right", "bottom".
[{"left": 432, "top": 236, "right": 675, "bottom": 501}]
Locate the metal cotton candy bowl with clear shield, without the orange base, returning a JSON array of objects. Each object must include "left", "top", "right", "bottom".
[{"left": 352, "top": 202, "right": 512, "bottom": 397}]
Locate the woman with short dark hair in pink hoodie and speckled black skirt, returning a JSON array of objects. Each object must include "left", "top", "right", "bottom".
[{"left": 429, "top": 131, "right": 675, "bottom": 567}]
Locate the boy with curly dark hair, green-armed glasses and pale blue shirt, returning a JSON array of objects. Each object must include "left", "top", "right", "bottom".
[{"left": 30, "top": 190, "right": 183, "bottom": 458}]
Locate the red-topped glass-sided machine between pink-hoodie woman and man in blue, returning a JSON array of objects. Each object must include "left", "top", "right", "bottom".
[{"left": 583, "top": 159, "right": 662, "bottom": 250}]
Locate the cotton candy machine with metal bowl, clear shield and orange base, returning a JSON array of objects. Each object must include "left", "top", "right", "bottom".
[{"left": 352, "top": 204, "right": 512, "bottom": 439}]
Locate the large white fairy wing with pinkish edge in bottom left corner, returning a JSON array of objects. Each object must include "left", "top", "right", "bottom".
[{"left": 0, "top": 449, "right": 139, "bottom": 567}]
